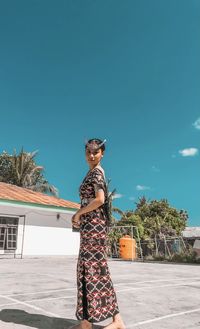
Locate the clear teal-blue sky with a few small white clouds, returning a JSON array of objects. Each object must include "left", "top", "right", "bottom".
[{"left": 0, "top": 0, "right": 200, "bottom": 226}]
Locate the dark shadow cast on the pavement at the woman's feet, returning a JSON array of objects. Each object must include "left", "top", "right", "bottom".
[{"left": 0, "top": 309, "right": 103, "bottom": 329}]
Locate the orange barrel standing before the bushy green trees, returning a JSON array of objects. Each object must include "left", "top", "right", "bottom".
[{"left": 119, "top": 235, "right": 136, "bottom": 259}]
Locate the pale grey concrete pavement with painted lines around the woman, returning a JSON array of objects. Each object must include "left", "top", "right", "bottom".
[{"left": 0, "top": 256, "right": 200, "bottom": 329}]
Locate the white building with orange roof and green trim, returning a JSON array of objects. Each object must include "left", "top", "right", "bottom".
[{"left": 0, "top": 182, "right": 80, "bottom": 257}]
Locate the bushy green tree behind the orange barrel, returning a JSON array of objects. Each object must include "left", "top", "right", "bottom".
[{"left": 109, "top": 197, "right": 188, "bottom": 255}]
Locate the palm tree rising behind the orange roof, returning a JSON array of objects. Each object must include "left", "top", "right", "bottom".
[{"left": 0, "top": 149, "right": 58, "bottom": 196}]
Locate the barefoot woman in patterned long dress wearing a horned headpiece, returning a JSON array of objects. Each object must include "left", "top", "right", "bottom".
[{"left": 72, "top": 139, "right": 125, "bottom": 329}]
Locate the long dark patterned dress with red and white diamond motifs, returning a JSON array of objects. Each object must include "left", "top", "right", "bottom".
[{"left": 76, "top": 166, "right": 119, "bottom": 323}]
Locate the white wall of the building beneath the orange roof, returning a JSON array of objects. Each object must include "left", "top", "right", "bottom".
[{"left": 0, "top": 205, "right": 80, "bottom": 256}]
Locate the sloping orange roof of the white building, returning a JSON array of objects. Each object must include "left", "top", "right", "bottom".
[{"left": 0, "top": 182, "right": 80, "bottom": 209}]
